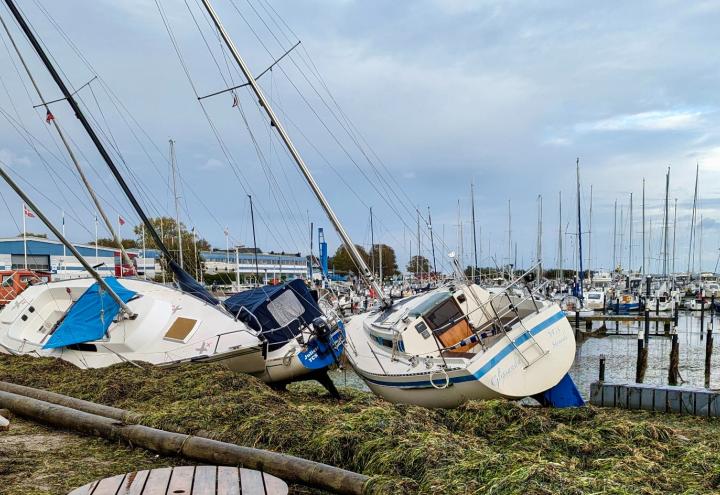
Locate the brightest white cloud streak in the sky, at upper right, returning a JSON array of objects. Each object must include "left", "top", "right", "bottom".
[{"left": 576, "top": 111, "right": 703, "bottom": 132}]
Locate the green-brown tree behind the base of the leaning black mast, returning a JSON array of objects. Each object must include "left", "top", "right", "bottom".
[{"left": 133, "top": 217, "right": 210, "bottom": 280}]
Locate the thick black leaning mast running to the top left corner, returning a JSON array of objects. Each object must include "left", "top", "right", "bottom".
[{"left": 5, "top": 0, "right": 172, "bottom": 268}]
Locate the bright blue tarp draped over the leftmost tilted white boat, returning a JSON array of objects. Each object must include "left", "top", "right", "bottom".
[{"left": 43, "top": 277, "right": 135, "bottom": 349}]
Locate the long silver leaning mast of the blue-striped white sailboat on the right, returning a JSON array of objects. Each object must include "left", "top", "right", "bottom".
[{"left": 197, "top": 0, "right": 391, "bottom": 306}]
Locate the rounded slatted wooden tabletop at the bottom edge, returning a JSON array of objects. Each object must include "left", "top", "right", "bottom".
[{"left": 69, "top": 466, "right": 288, "bottom": 495}]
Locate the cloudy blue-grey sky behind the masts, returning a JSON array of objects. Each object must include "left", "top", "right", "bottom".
[{"left": 0, "top": 0, "right": 720, "bottom": 272}]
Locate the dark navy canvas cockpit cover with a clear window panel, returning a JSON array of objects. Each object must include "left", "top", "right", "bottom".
[{"left": 223, "top": 279, "right": 322, "bottom": 350}]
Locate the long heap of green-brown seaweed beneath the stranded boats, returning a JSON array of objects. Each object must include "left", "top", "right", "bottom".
[{"left": 0, "top": 356, "right": 720, "bottom": 494}]
